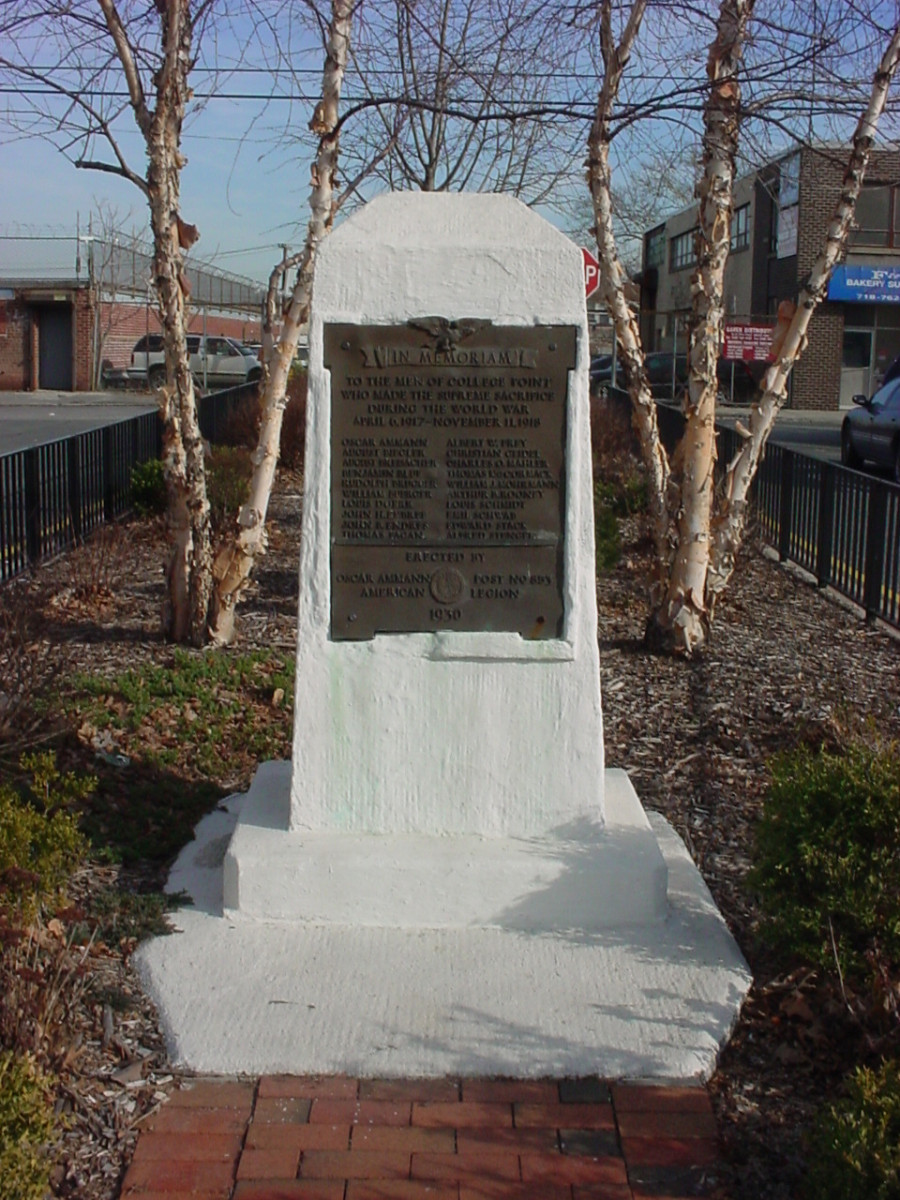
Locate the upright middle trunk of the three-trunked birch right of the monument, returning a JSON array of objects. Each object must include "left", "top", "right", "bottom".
[{"left": 652, "top": 0, "right": 754, "bottom": 655}]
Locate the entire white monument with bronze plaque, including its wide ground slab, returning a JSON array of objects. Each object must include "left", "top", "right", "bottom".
[{"left": 136, "top": 194, "right": 750, "bottom": 1079}]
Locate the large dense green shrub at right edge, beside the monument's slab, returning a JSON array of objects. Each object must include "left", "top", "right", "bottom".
[{"left": 750, "top": 742, "right": 900, "bottom": 974}]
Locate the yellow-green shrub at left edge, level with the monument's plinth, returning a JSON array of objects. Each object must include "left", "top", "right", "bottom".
[{"left": 0, "top": 754, "right": 90, "bottom": 920}]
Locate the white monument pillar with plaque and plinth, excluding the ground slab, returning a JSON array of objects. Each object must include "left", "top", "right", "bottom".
[{"left": 224, "top": 193, "right": 667, "bottom": 931}]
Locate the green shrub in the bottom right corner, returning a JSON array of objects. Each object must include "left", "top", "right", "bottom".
[{"left": 805, "top": 1062, "right": 900, "bottom": 1200}]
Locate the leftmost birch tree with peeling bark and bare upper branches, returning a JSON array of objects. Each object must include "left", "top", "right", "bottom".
[{"left": 0, "top": 0, "right": 212, "bottom": 646}]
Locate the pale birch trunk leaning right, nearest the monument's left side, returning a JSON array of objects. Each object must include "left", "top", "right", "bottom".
[{"left": 209, "top": 0, "right": 354, "bottom": 644}]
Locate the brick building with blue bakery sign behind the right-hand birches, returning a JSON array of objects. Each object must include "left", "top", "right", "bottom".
[{"left": 641, "top": 146, "right": 900, "bottom": 409}]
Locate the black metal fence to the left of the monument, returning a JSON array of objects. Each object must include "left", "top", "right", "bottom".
[{"left": 0, "top": 384, "right": 258, "bottom": 582}]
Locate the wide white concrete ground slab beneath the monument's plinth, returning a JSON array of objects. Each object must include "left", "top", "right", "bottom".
[{"left": 134, "top": 772, "right": 751, "bottom": 1080}]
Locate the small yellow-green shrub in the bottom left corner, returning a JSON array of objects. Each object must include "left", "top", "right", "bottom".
[{"left": 0, "top": 1051, "right": 54, "bottom": 1200}]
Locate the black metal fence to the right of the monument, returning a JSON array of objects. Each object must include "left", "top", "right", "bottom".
[{"left": 656, "top": 404, "right": 900, "bottom": 628}]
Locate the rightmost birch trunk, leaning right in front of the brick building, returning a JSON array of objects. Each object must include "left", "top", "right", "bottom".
[{"left": 707, "top": 24, "right": 900, "bottom": 610}]
